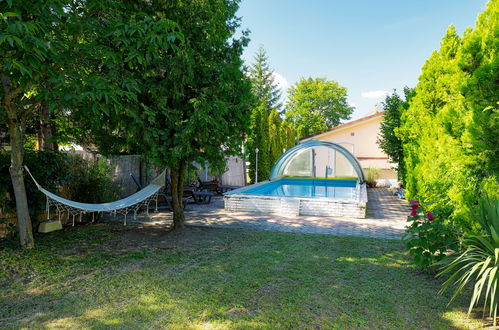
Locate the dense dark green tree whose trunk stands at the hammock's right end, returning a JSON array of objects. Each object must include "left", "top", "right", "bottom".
[{"left": 93, "top": 0, "right": 251, "bottom": 229}]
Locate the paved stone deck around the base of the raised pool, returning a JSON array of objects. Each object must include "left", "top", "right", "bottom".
[{"left": 133, "top": 188, "right": 410, "bottom": 239}]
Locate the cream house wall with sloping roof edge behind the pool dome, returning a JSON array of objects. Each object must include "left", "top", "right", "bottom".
[{"left": 300, "top": 112, "right": 398, "bottom": 186}]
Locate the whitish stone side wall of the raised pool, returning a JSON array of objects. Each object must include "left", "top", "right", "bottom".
[{"left": 224, "top": 181, "right": 367, "bottom": 219}]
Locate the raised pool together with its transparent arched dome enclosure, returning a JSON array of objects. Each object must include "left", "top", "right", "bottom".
[{"left": 224, "top": 140, "right": 367, "bottom": 218}]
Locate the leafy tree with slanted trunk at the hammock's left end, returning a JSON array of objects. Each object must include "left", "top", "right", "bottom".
[{"left": 0, "top": 0, "right": 184, "bottom": 248}]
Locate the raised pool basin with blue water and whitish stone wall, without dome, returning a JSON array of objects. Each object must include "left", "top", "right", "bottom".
[{"left": 224, "top": 178, "right": 367, "bottom": 218}]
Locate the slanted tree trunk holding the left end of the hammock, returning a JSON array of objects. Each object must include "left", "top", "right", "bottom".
[{"left": 0, "top": 72, "right": 35, "bottom": 249}]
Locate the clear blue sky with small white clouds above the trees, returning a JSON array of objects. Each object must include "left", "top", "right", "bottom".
[{"left": 238, "top": 0, "right": 487, "bottom": 119}]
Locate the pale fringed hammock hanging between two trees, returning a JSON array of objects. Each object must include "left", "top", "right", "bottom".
[{"left": 24, "top": 166, "right": 166, "bottom": 226}]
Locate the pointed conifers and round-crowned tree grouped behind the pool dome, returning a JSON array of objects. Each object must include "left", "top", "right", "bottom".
[{"left": 246, "top": 47, "right": 354, "bottom": 182}]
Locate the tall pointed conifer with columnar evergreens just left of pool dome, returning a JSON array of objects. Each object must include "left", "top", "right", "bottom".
[{"left": 246, "top": 47, "right": 296, "bottom": 182}]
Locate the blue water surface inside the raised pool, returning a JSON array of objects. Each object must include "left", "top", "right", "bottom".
[{"left": 241, "top": 178, "right": 357, "bottom": 199}]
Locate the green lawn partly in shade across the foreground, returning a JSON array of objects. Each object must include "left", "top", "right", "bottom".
[{"left": 0, "top": 224, "right": 483, "bottom": 329}]
